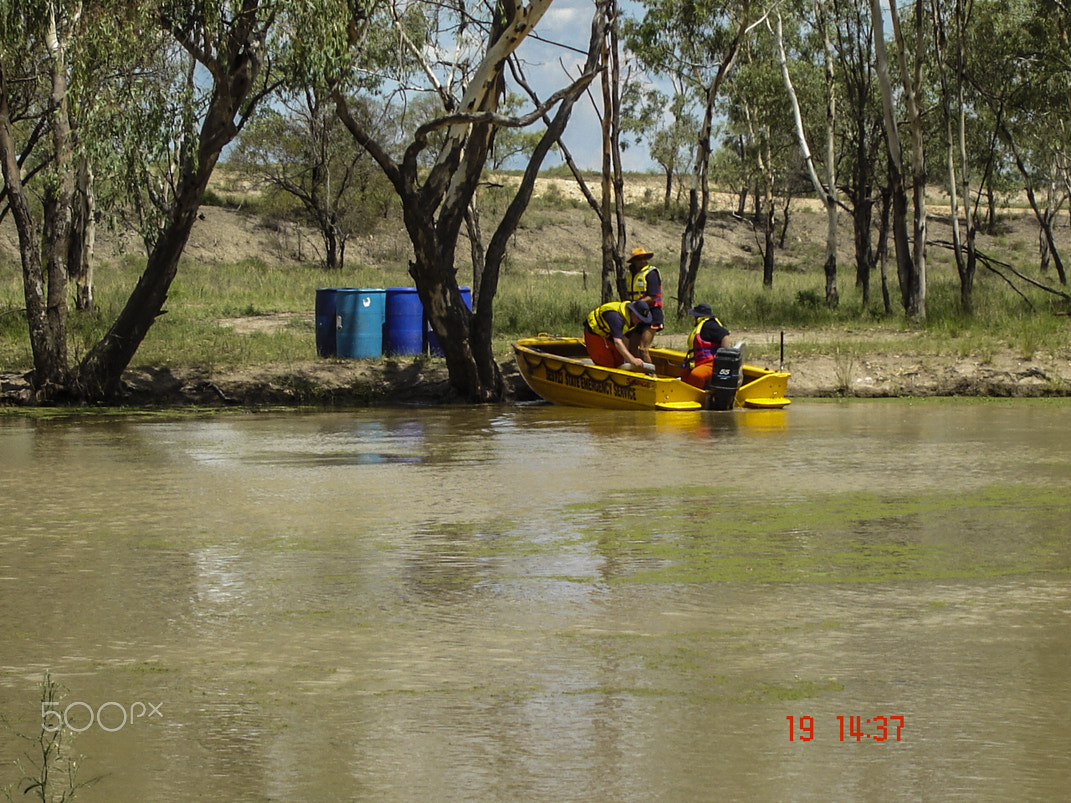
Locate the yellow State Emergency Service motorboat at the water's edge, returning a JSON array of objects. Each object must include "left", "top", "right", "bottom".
[{"left": 513, "top": 335, "right": 790, "bottom": 410}]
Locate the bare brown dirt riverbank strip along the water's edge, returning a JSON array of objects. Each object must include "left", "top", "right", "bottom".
[{"left": 0, "top": 337, "right": 1071, "bottom": 408}]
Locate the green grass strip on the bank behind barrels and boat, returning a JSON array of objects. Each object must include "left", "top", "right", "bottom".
[{"left": 0, "top": 209, "right": 1071, "bottom": 372}]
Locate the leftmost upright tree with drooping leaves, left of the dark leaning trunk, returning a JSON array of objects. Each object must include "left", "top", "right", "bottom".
[{"left": 0, "top": 0, "right": 152, "bottom": 387}]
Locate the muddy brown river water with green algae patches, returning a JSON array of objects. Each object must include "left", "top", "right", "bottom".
[{"left": 0, "top": 400, "right": 1071, "bottom": 802}]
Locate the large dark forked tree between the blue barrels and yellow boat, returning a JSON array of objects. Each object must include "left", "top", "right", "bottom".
[{"left": 296, "top": 0, "right": 608, "bottom": 403}]
